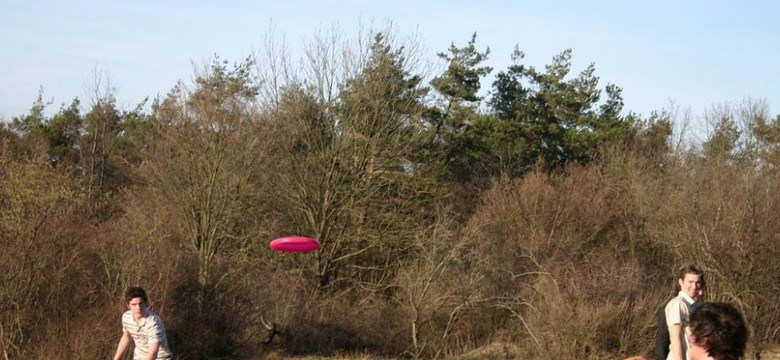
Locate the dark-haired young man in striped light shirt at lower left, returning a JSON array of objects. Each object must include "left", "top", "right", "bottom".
[{"left": 114, "top": 287, "right": 173, "bottom": 360}]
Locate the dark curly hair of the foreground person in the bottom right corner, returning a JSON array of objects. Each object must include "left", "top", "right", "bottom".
[{"left": 690, "top": 302, "right": 748, "bottom": 360}]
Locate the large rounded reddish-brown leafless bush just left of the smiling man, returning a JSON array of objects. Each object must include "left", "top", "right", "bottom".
[{"left": 470, "top": 154, "right": 669, "bottom": 358}]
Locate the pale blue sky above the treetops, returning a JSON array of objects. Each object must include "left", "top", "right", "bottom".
[{"left": 0, "top": 0, "right": 780, "bottom": 125}]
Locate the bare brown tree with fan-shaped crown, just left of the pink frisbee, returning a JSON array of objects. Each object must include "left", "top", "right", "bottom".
[{"left": 141, "top": 58, "right": 266, "bottom": 311}]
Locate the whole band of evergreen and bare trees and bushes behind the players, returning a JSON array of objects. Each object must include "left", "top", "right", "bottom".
[{"left": 0, "top": 32, "right": 780, "bottom": 359}]
